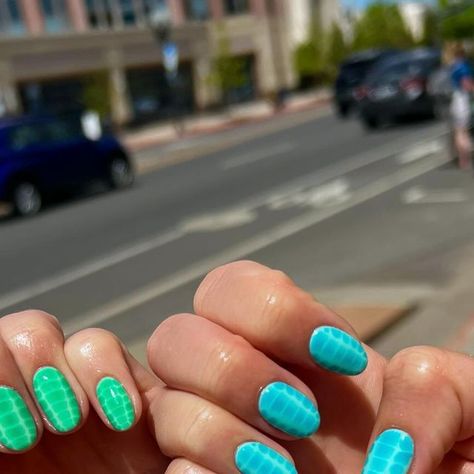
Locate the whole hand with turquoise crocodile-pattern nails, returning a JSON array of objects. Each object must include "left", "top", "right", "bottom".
[{"left": 148, "top": 262, "right": 474, "bottom": 474}]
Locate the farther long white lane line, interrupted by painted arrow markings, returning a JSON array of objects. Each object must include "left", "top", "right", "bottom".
[{"left": 0, "top": 131, "right": 448, "bottom": 310}]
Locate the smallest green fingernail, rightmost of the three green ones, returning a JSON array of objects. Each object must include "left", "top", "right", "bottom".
[{"left": 96, "top": 377, "right": 135, "bottom": 431}]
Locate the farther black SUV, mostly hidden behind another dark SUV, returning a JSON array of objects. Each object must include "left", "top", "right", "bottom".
[{"left": 334, "top": 49, "right": 397, "bottom": 117}]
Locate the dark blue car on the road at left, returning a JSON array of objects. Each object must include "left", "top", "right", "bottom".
[{"left": 0, "top": 117, "right": 134, "bottom": 216}]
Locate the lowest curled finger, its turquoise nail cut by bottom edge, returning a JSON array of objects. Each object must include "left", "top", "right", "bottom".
[{"left": 149, "top": 389, "right": 296, "bottom": 474}]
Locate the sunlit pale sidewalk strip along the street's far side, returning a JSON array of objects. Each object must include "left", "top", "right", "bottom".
[{"left": 121, "top": 88, "right": 332, "bottom": 152}]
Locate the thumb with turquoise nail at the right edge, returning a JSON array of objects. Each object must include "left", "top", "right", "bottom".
[{"left": 363, "top": 347, "right": 474, "bottom": 474}]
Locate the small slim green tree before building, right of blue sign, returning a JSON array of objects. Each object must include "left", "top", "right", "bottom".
[{"left": 209, "top": 24, "right": 247, "bottom": 102}]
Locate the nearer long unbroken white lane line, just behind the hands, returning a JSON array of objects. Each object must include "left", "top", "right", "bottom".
[{"left": 65, "top": 153, "right": 448, "bottom": 333}]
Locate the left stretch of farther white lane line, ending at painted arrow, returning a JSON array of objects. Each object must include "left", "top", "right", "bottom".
[{"left": 0, "top": 229, "right": 184, "bottom": 309}]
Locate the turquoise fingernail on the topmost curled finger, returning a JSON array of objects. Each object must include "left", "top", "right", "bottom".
[{"left": 309, "top": 326, "right": 367, "bottom": 375}]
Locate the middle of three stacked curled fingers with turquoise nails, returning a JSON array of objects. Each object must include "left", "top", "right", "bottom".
[{"left": 148, "top": 315, "right": 320, "bottom": 439}]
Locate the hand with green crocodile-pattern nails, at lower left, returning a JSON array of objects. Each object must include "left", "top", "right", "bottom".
[{"left": 0, "top": 311, "right": 169, "bottom": 474}]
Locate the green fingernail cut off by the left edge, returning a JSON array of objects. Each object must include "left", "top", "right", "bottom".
[{"left": 0, "top": 387, "right": 38, "bottom": 451}]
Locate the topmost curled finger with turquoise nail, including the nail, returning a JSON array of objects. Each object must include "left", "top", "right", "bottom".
[{"left": 194, "top": 262, "right": 367, "bottom": 375}]
